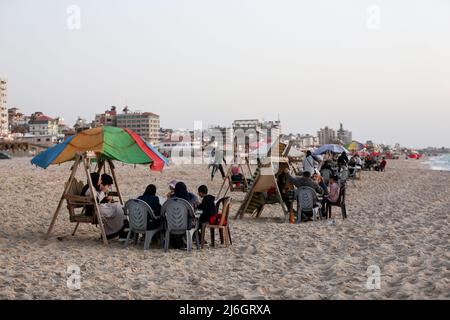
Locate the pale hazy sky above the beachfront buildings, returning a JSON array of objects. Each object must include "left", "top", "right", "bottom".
[{"left": 0, "top": 0, "right": 450, "bottom": 147}]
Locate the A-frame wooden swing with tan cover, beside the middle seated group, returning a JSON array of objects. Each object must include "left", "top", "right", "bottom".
[{"left": 235, "top": 160, "right": 289, "bottom": 219}]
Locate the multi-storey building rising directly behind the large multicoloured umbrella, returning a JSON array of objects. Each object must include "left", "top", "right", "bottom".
[{"left": 117, "top": 109, "right": 160, "bottom": 145}]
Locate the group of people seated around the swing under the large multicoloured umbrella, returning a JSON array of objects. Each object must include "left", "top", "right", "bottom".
[{"left": 81, "top": 172, "right": 220, "bottom": 239}]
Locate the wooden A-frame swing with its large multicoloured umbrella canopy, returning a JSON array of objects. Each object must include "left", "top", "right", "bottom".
[{"left": 31, "top": 126, "right": 168, "bottom": 244}]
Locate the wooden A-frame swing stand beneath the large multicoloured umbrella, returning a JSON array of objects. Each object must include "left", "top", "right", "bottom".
[{"left": 44, "top": 152, "right": 124, "bottom": 245}]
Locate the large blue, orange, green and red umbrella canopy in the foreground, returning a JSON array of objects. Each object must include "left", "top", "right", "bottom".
[{"left": 31, "top": 126, "right": 168, "bottom": 171}]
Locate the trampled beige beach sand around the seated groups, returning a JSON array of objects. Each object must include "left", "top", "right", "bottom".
[{"left": 0, "top": 158, "right": 450, "bottom": 299}]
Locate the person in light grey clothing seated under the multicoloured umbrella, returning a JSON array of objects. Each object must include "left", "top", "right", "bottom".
[{"left": 85, "top": 174, "right": 126, "bottom": 239}]
